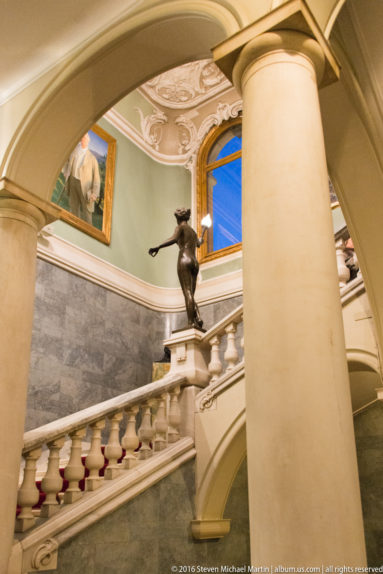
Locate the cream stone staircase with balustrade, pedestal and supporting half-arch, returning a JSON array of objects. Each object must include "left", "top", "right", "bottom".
[{"left": 7, "top": 259, "right": 365, "bottom": 574}]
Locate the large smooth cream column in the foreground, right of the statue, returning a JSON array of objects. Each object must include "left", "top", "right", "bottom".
[{"left": 233, "top": 31, "right": 365, "bottom": 567}]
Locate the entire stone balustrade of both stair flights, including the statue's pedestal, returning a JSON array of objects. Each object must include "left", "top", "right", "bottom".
[{"left": 16, "top": 228, "right": 359, "bottom": 532}]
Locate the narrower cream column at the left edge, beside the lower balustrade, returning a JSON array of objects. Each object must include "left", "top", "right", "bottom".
[{"left": 0, "top": 197, "right": 46, "bottom": 573}]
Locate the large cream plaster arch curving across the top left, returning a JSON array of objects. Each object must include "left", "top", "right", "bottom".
[{"left": 1, "top": 0, "right": 239, "bottom": 204}]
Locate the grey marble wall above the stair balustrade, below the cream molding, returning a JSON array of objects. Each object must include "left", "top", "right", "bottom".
[{"left": 25, "top": 260, "right": 240, "bottom": 430}]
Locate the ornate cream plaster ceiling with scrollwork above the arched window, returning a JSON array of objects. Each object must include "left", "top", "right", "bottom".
[{"left": 105, "top": 59, "right": 242, "bottom": 168}]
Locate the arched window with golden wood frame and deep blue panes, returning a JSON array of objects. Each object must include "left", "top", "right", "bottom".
[{"left": 197, "top": 118, "right": 242, "bottom": 262}]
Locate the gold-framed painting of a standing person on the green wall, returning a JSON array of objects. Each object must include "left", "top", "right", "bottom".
[{"left": 51, "top": 125, "right": 116, "bottom": 245}]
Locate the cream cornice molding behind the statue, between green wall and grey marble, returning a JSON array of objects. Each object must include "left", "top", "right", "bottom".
[{"left": 37, "top": 229, "right": 242, "bottom": 312}]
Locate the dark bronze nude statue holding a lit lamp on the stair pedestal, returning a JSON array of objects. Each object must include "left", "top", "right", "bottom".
[{"left": 149, "top": 207, "right": 207, "bottom": 329}]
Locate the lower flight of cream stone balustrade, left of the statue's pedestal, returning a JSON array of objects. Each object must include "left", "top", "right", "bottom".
[{"left": 15, "top": 375, "right": 186, "bottom": 532}]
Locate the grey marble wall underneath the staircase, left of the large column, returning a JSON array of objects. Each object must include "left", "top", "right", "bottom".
[{"left": 43, "top": 461, "right": 250, "bottom": 574}]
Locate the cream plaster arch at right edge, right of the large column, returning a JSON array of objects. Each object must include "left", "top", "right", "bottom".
[{"left": 320, "top": 0, "right": 383, "bottom": 364}]
